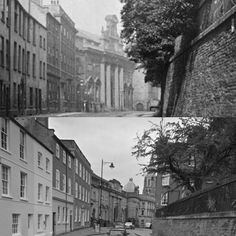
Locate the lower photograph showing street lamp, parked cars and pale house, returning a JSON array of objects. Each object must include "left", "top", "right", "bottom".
[{"left": 0, "top": 117, "right": 236, "bottom": 236}]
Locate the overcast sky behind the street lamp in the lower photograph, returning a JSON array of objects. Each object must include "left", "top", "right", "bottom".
[{"left": 49, "top": 117, "right": 159, "bottom": 191}]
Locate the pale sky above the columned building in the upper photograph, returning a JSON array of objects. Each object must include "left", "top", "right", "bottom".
[{"left": 60, "top": 0, "right": 122, "bottom": 35}]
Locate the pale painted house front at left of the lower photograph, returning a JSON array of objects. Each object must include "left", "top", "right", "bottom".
[{"left": 0, "top": 118, "right": 52, "bottom": 236}]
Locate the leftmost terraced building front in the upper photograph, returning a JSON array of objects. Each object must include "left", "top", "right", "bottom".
[{"left": 0, "top": 0, "right": 47, "bottom": 115}]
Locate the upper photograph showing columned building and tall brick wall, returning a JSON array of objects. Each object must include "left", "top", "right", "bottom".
[{"left": 0, "top": 0, "right": 236, "bottom": 117}]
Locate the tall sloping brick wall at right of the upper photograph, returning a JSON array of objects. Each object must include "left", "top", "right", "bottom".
[{"left": 164, "top": 6, "right": 236, "bottom": 116}]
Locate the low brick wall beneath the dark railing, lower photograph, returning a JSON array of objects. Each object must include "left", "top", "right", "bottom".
[{"left": 152, "top": 211, "right": 236, "bottom": 236}]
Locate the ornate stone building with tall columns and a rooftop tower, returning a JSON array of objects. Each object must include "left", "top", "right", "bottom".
[{"left": 76, "top": 15, "right": 134, "bottom": 111}]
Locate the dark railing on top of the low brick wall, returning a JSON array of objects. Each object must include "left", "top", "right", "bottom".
[{"left": 156, "top": 179, "right": 236, "bottom": 217}]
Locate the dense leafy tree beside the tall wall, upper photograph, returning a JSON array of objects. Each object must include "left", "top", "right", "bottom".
[{"left": 120, "top": 0, "right": 198, "bottom": 115}]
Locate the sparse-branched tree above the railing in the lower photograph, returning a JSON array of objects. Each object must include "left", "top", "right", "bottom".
[{"left": 133, "top": 118, "right": 236, "bottom": 192}]
